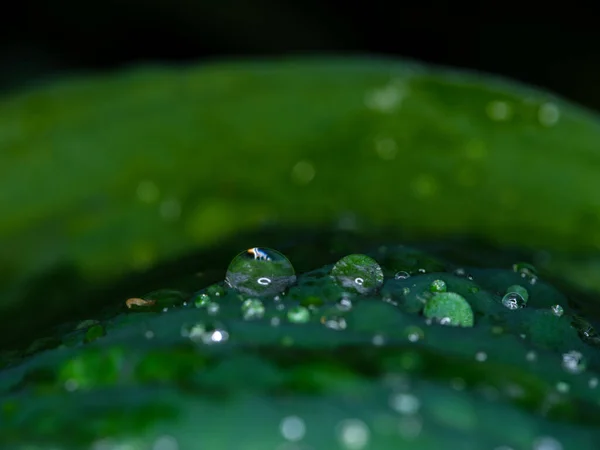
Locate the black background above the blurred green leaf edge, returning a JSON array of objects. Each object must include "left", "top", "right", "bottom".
[{"left": 0, "top": 0, "right": 600, "bottom": 110}]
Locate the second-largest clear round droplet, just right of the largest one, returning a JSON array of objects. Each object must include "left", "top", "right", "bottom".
[{"left": 331, "top": 254, "right": 383, "bottom": 294}]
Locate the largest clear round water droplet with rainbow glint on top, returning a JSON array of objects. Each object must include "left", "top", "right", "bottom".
[{"left": 225, "top": 247, "right": 296, "bottom": 296}]
